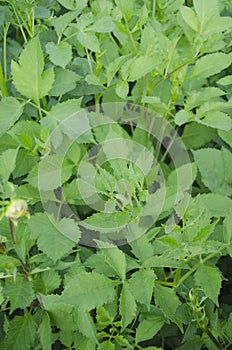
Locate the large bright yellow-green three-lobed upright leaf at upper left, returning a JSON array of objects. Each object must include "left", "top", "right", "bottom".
[{"left": 11, "top": 37, "right": 54, "bottom": 104}]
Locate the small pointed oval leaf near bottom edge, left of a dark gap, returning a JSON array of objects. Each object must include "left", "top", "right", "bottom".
[{"left": 135, "top": 316, "right": 164, "bottom": 344}]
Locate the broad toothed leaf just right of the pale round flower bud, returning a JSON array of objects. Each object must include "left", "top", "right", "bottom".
[{"left": 28, "top": 213, "right": 75, "bottom": 262}]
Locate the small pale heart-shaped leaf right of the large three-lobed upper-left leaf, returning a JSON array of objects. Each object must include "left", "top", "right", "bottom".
[{"left": 46, "top": 42, "right": 72, "bottom": 68}]
